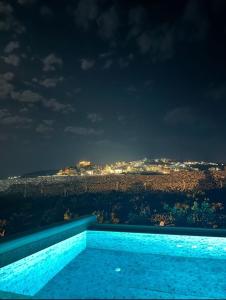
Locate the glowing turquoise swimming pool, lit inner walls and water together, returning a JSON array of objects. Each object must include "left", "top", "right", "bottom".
[{"left": 0, "top": 231, "right": 226, "bottom": 299}]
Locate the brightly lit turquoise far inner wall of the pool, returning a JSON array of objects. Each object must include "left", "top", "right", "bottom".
[{"left": 86, "top": 230, "right": 226, "bottom": 260}]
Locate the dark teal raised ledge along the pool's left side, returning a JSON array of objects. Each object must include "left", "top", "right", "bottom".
[{"left": 0, "top": 216, "right": 96, "bottom": 268}]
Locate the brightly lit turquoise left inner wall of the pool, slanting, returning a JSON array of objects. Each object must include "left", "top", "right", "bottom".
[{"left": 0, "top": 231, "right": 86, "bottom": 296}]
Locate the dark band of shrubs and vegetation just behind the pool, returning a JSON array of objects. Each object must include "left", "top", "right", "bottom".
[{"left": 0, "top": 189, "right": 226, "bottom": 238}]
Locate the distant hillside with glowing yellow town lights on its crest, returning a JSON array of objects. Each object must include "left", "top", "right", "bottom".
[{"left": 0, "top": 159, "right": 226, "bottom": 197}]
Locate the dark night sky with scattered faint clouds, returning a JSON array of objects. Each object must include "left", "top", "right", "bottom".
[{"left": 0, "top": 0, "right": 226, "bottom": 176}]
